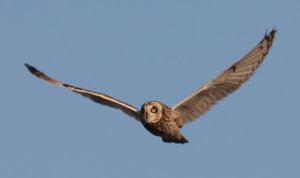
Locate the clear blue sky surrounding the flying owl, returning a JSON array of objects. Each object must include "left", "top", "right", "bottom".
[{"left": 0, "top": 0, "right": 300, "bottom": 178}]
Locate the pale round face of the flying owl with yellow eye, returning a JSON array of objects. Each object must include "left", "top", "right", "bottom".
[{"left": 140, "top": 101, "right": 163, "bottom": 124}]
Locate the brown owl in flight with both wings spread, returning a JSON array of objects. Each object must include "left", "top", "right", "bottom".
[{"left": 25, "top": 28, "right": 277, "bottom": 144}]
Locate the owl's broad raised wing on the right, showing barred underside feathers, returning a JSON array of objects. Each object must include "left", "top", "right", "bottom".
[{"left": 172, "top": 28, "right": 276, "bottom": 126}]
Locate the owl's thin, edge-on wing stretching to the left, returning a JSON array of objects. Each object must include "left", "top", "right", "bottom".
[{"left": 25, "top": 64, "right": 140, "bottom": 121}]
